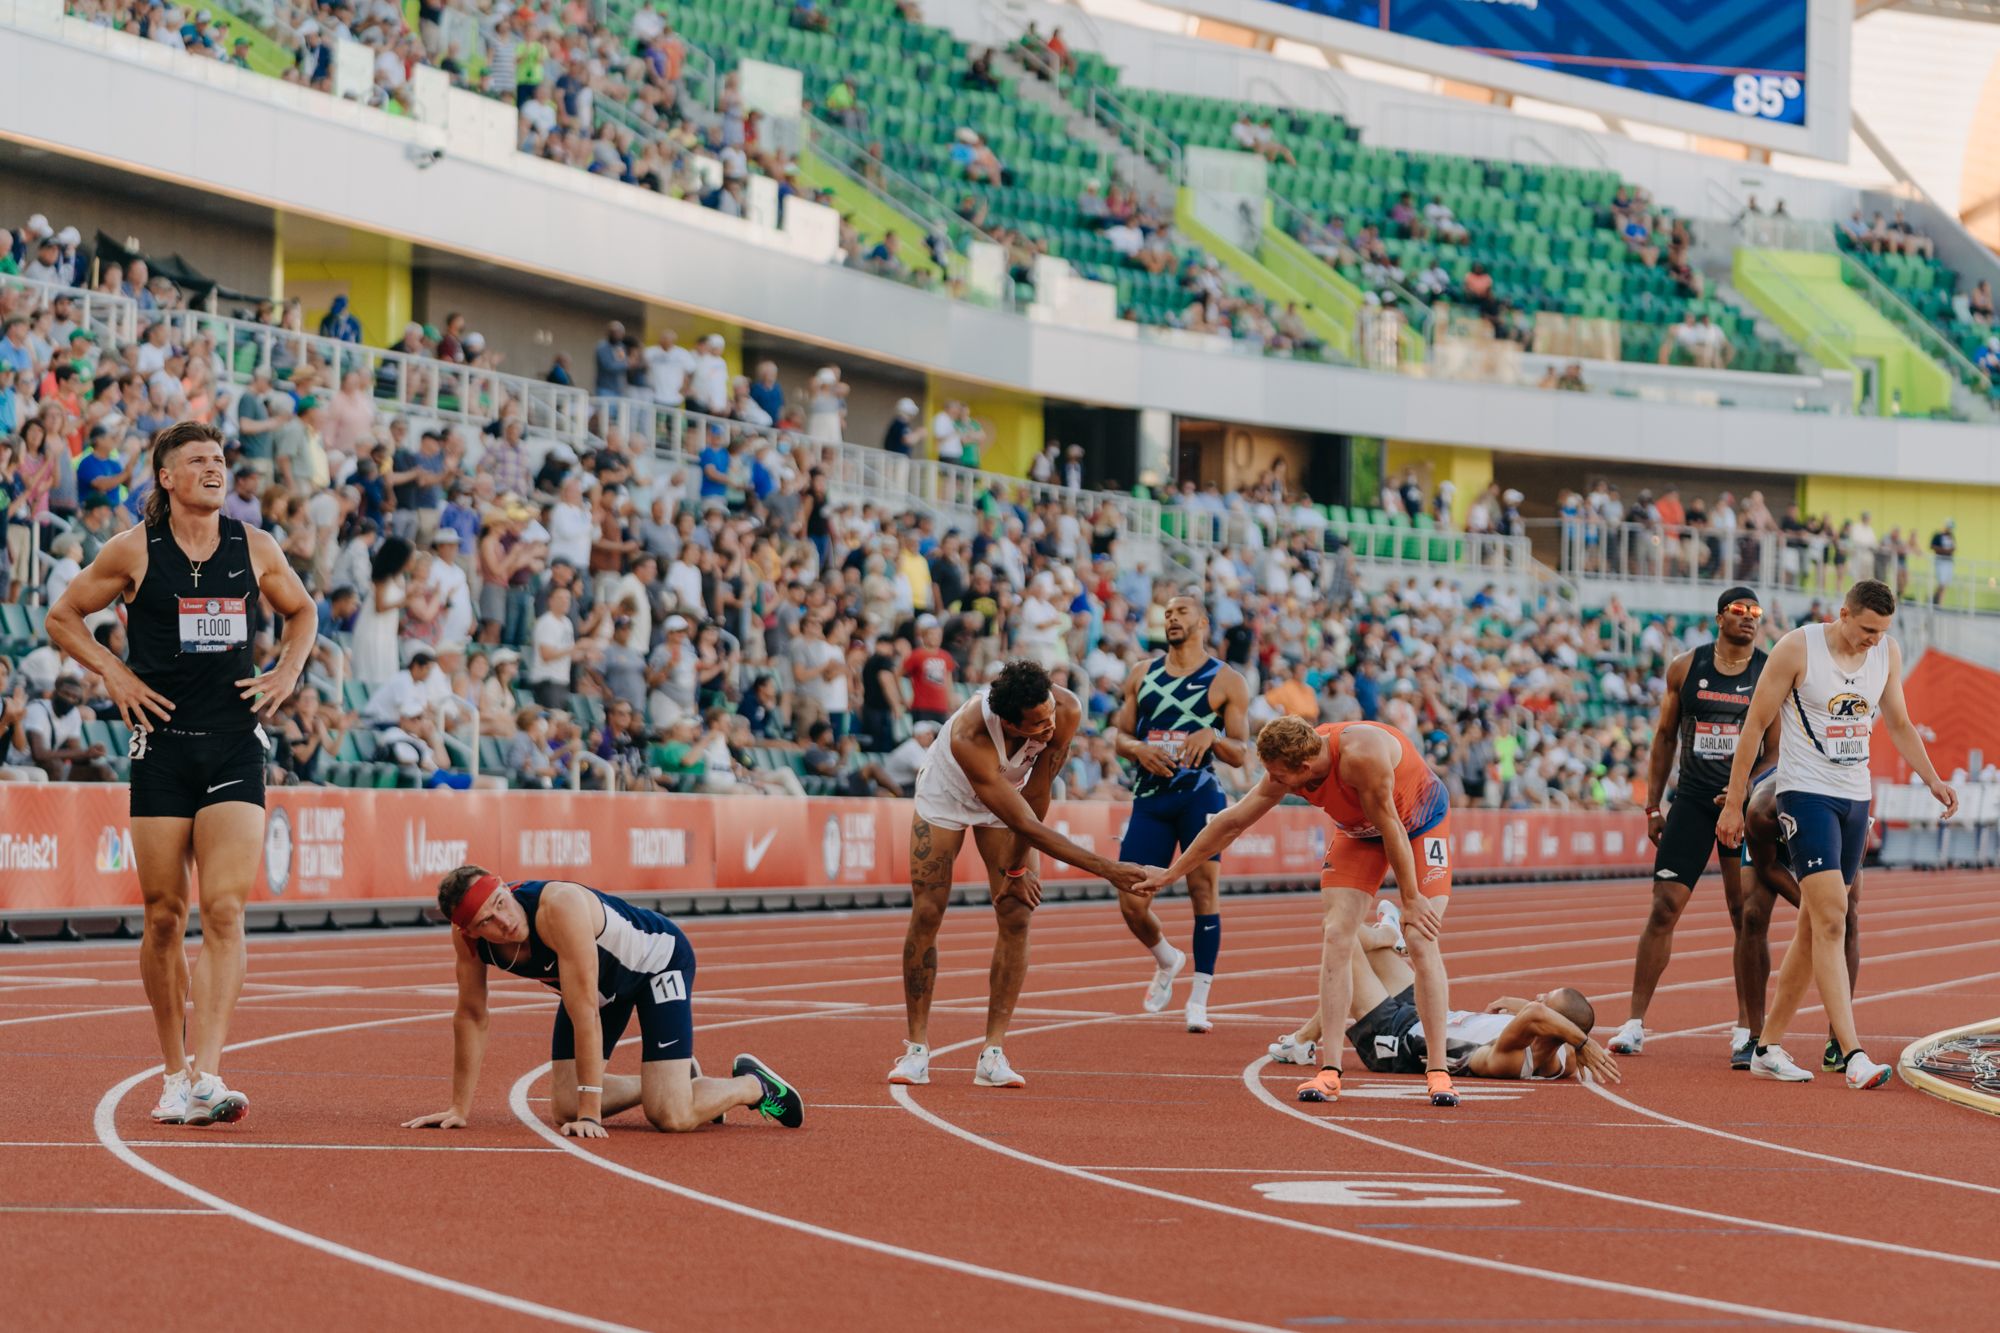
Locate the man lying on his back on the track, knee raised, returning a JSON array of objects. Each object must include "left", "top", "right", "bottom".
[{"left": 1270, "top": 903, "right": 1618, "bottom": 1083}]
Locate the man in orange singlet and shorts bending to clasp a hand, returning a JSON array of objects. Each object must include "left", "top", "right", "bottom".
[{"left": 1138, "top": 717, "right": 1458, "bottom": 1107}]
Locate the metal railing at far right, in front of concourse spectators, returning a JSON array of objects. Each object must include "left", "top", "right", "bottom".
[{"left": 1528, "top": 518, "right": 2000, "bottom": 614}]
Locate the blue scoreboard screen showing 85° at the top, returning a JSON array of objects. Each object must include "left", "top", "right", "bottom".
[{"left": 1270, "top": 0, "right": 1810, "bottom": 126}]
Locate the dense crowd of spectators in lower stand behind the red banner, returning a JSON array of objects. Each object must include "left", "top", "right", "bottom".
[{"left": 0, "top": 214, "right": 1696, "bottom": 805}]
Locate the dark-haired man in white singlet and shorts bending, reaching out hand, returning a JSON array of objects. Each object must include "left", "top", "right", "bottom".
[{"left": 888, "top": 660, "right": 1146, "bottom": 1087}]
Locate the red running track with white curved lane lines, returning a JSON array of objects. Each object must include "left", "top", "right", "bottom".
[{"left": 0, "top": 875, "right": 2000, "bottom": 1329}]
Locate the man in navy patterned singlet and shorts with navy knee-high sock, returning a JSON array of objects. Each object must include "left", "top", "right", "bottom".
[{"left": 1112, "top": 594, "right": 1250, "bottom": 1033}]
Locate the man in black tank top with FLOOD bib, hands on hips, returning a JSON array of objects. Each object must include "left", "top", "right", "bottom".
[{"left": 48, "top": 420, "right": 318, "bottom": 1125}]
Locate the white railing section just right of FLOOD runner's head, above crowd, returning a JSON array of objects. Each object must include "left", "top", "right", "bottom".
[{"left": 162, "top": 310, "right": 590, "bottom": 444}]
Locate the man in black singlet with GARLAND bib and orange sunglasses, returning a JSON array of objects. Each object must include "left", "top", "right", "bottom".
[{"left": 1606, "top": 586, "right": 1778, "bottom": 1067}]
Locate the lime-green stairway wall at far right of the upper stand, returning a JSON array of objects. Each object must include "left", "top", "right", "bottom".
[{"left": 1734, "top": 248, "right": 1952, "bottom": 416}]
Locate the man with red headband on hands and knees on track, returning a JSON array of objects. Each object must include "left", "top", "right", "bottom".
[{"left": 404, "top": 865, "right": 804, "bottom": 1139}]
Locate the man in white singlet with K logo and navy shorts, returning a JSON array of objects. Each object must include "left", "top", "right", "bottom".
[{"left": 1716, "top": 578, "right": 1958, "bottom": 1089}]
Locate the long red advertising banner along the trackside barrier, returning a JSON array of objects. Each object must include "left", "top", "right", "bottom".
[{"left": 0, "top": 785, "right": 1652, "bottom": 913}]
